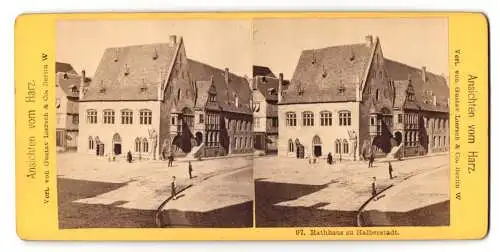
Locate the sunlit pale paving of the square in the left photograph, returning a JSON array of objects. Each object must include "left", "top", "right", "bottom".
[{"left": 57, "top": 153, "right": 253, "bottom": 210}]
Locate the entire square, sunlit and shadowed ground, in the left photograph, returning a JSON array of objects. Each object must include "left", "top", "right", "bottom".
[{"left": 58, "top": 153, "right": 253, "bottom": 227}]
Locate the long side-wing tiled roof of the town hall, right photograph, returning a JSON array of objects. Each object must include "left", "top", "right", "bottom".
[{"left": 384, "top": 59, "right": 450, "bottom": 112}]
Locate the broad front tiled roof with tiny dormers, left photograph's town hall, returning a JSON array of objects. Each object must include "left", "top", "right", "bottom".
[{"left": 84, "top": 42, "right": 182, "bottom": 100}]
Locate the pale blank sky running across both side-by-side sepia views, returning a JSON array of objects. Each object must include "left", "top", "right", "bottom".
[{"left": 56, "top": 18, "right": 448, "bottom": 79}]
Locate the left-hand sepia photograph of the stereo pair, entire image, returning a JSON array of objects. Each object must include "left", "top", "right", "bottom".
[{"left": 55, "top": 20, "right": 255, "bottom": 229}]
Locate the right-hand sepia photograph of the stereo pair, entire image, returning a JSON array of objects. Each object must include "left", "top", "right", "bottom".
[{"left": 252, "top": 18, "right": 450, "bottom": 227}]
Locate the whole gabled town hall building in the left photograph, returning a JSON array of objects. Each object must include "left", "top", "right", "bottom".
[{"left": 78, "top": 35, "right": 252, "bottom": 159}]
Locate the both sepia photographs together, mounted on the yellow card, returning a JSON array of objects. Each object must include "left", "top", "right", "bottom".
[{"left": 55, "top": 18, "right": 450, "bottom": 229}]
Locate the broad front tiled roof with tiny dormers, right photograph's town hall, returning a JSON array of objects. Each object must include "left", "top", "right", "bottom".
[{"left": 281, "top": 44, "right": 373, "bottom": 104}]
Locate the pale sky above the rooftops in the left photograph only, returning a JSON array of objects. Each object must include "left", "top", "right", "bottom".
[{"left": 56, "top": 20, "right": 252, "bottom": 76}]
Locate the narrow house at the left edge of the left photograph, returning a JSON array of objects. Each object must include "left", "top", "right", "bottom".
[{"left": 56, "top": 62, "right": 89, "bottom": 151}]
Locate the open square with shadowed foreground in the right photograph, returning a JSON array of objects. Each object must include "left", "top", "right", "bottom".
[{"left": 254, "top": 155, "right": 449, "bottom": 226}]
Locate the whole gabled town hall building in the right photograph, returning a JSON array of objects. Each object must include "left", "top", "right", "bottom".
[{"left": 278, "top": 36, "right": 449, "bottom": 159}]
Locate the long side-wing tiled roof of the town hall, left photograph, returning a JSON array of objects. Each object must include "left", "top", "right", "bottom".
[{"left": 188, "top": 59, "right": 252, "bottom": 114}]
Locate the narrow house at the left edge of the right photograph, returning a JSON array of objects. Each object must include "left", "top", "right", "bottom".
[{"left": 252, "top": 66, "right": 289, "bottom": 153}]
